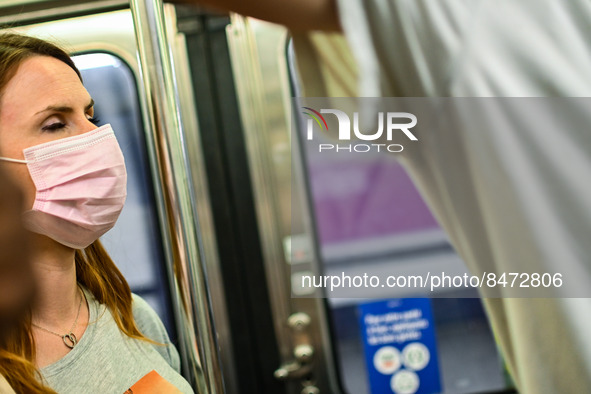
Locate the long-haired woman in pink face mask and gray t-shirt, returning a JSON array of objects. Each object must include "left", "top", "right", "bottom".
[{"left": 0, "top": 34, "right": 192, "bottom": 393}]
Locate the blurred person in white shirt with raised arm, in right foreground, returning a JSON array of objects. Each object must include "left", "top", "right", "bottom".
[{"left": 175, "top": 0, "right": 591, "bottom": 393}]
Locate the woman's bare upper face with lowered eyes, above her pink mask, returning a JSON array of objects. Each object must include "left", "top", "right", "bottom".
[{"left": 0, "top": 56, "right": 96, "bottom": 207}]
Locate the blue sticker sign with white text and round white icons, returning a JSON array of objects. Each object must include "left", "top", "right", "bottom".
[{"left": 359, "top": 298, "right": 441, "bottom": 394}]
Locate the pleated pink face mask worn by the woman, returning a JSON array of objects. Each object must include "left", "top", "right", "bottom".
[{"left": 0, "top": 125, "right": 127, "bottom": 249}]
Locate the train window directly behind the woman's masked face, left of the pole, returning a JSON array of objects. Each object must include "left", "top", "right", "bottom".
[{"left": 73, "top": 52, "right": 174, "bottom": 335}]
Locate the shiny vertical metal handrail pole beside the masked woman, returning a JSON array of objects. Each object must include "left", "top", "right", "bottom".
[{"left": 130, "top": 0, "right": 224, "bottom": 394}]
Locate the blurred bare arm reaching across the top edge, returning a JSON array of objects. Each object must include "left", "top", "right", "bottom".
[{"left": 171, "top": 0, "right": 341, "bottom": 31}]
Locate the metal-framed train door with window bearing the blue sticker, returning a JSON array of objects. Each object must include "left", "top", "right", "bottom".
[{"left": 228, "top": 17, "right": 513, "bottom": 394}]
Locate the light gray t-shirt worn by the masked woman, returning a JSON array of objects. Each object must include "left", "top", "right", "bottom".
[{"left": 41, "top": 289, "right": 193, "bottom": 394}]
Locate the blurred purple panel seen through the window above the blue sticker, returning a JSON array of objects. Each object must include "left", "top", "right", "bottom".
[{"left": 307, "top": 137, "right": 438, "bottom": 245}]
